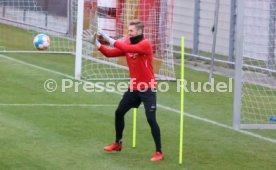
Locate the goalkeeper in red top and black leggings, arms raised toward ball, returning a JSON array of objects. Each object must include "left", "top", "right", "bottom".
[{"left": 84, "top": 20, "right": 164, "bottom": 161}]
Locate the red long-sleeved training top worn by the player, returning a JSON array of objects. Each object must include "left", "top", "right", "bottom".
[{"left": 99, "top": 37, "right": 156, "bottom": 90}]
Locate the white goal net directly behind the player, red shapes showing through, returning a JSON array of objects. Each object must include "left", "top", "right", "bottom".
[{"left": 76, "top": 0, "right": 175, "bottom": 80}]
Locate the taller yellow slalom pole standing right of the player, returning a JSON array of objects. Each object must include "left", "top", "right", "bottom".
[{"left": 179, "top": 37, "right": 185, "bottom": 164}]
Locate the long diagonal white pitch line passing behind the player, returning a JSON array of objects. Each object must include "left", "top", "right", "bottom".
[{"left": 0, "top": 54, "right": 276, "bottom": 144}]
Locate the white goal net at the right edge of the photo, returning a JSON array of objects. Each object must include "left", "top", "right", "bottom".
[{"left": 235, "top": 0, "right": 276, "bottom": 129}]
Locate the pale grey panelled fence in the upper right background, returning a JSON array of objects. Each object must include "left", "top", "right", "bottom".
[{"left": 173, "top": 0, "right": 276, "bottom": 68}]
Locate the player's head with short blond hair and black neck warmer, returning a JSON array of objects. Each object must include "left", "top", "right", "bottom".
[{"left": 128, "top": 20, "right": 144, "bottom": 44}]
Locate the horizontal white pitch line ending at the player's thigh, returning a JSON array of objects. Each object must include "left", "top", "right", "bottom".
[{"left": 0, "top": 103, "right": 117, "bottom": 107}]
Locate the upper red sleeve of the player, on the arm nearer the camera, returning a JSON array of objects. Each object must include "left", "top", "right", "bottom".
[{"left": 114, "top": 40, "right": 152, "bottom": 55}]
